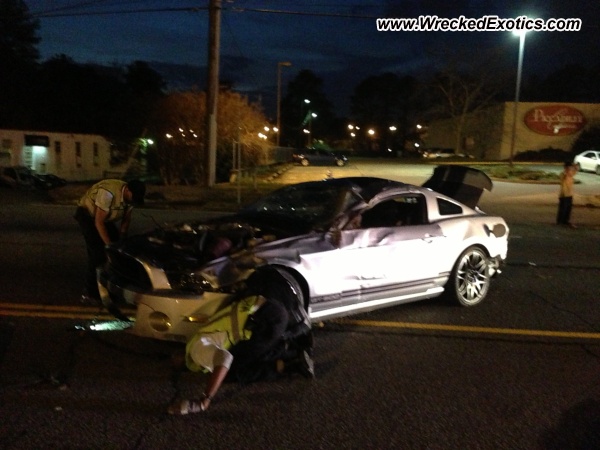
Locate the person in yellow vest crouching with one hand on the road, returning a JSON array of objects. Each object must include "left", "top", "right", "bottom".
[{"left": 167, "top": 295, "right": 312, "bottom": 415}]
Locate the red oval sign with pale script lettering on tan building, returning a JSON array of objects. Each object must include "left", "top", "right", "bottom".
[{"left": 523, "top": 105, "right": 586, "bottom": 136}]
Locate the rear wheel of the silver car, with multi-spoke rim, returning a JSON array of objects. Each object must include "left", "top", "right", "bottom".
[{"left": 446, "top": 246, "right": 491, "bottom": 306}]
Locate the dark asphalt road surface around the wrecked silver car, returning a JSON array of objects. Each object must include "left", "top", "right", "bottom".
[{"left": 0, "top": 163, "right": 600, "bottom": 449}]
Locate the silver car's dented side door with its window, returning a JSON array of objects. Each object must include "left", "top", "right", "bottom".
[{"left": 340, "top": 194, "right": 445, "bottom": 307}]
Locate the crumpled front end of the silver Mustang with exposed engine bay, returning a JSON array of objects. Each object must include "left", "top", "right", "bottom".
[{"left": 97, "top": 223, "right": 288, "bottom": 341}]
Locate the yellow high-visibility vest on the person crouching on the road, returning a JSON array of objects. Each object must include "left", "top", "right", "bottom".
[{"left": 186, "top": 295, "right": 266, "bottom": 370}]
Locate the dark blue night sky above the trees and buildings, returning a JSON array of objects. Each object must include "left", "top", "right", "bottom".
[{"left": 31, "top": 0, "right": 600, "bottom": 114}]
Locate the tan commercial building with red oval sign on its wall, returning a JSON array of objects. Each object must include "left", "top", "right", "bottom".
[{"left": 423, "top": 102, "right": 600, "bottom": 160}]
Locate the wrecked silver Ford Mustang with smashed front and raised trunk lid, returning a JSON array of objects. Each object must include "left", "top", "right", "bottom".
[{"left": 98, "top": 166, "right": 509, "bottom": 341}]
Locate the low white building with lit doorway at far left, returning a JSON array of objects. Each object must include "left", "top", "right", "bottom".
[{"left": 0, "top": 130, "right": 114, "bottom": 181}]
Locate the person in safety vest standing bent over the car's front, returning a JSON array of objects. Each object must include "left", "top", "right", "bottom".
[{"left": 75, "top": 179, "right": 146, "bottom": 303}]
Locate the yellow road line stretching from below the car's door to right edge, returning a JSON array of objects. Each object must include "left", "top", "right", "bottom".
[{"left": 333, "top": 319, "right": 600, "bottom": 339}]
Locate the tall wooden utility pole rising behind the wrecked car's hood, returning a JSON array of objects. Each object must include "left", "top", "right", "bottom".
[{"left": 204, "top": 0, "right": 221, "bottom": 187}]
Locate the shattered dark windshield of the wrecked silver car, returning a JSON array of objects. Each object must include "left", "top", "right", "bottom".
[{"left": 241, "top": 182, "right": 358, "bottom": 227}]
